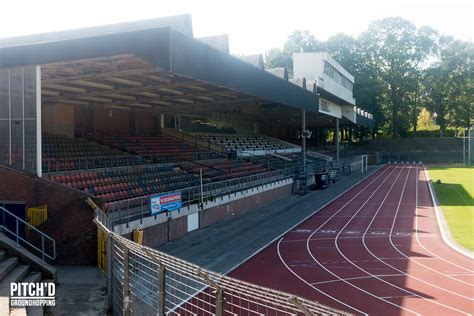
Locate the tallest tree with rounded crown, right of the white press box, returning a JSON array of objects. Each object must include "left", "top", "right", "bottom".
[{"left": 358, "top": 18, "right": 434, "bottom": 137}]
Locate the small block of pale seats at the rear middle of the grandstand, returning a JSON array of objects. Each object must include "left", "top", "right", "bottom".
[{"left": 201, "top": 135, "right": 291, "bottom": 151}]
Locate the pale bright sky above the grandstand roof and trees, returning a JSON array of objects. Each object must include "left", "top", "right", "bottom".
[{"left": 0, "top": 0, "right": 474, "bottom": 55}]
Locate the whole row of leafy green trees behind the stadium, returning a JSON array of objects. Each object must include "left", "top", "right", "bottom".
[{"left": 265, "top": 17, "right": 474, "bottom": 138}]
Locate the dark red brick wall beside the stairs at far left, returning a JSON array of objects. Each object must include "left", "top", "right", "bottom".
[{"left": 0, "top": 166, "right": 97, "bottom": 264}]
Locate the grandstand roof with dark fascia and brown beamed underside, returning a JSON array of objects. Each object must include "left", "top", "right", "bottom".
[{"left": 0, "top": 21, "right": 324, "bottom": 118}]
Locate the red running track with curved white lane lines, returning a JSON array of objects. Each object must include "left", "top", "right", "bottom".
[{"left": 231, "top": 164, "right": 474, "bottom": 315}]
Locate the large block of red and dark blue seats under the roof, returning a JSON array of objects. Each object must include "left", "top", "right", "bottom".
[{"left": 43, "top": 134, "right": 284, "bottom": 203}]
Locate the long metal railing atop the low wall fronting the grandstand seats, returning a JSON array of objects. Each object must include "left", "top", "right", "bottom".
[{"left": 107, "top": 163, "right": 329, "bottom": 226}]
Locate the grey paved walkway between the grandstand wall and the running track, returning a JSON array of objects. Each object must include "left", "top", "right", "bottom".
[{"left": 157, "top": 167, "right": 378, "bottom": 273}]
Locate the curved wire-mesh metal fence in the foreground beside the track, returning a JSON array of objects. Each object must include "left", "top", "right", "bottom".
[{"left": 95, "top": 215, "right": 347, "bottom": 316}]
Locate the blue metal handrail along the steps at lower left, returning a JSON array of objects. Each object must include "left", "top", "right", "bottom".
[{"left": 0, "top": 207, "right": 56, "bottom": 261}]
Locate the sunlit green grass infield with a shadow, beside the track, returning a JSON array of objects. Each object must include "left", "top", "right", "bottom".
[{"left": 428, "top": 165, "right": 474, "bottom": 250}]
